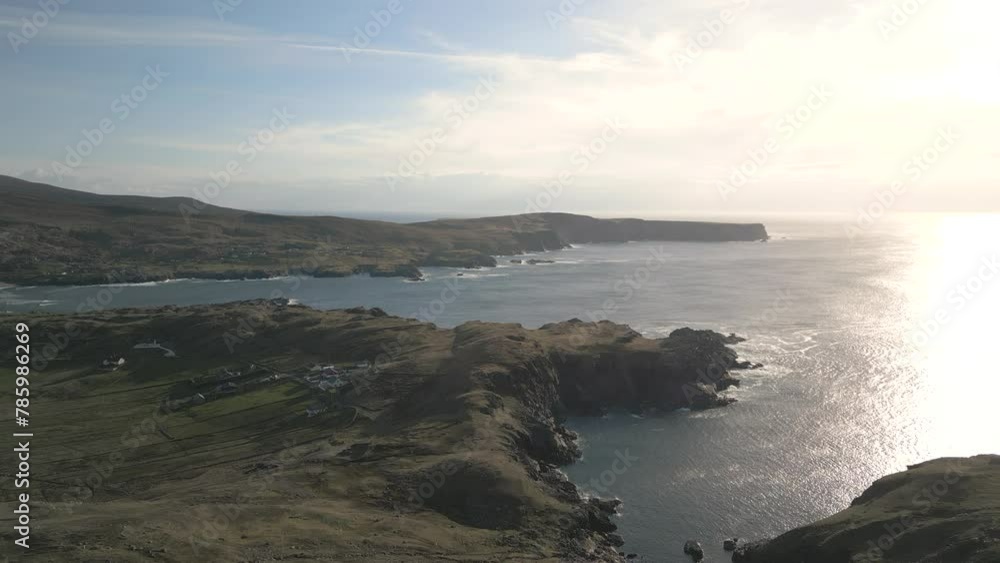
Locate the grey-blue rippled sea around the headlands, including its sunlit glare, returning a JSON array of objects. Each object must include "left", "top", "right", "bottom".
[{"left": 0, "top": 215, "right": 1000, "bottom": 562}]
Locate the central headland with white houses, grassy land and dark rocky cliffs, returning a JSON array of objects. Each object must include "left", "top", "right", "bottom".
[{"left": 0, "top": 301, "right": 752, "bottom": 562}]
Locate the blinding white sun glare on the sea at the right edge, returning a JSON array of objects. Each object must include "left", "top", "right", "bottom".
[{"left": 907, "top": 215, "right": 1000, "bottom": 457}]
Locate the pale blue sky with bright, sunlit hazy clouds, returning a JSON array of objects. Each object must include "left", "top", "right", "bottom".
[{"left": 0, "top": 0, "right": 1000, "bottom": 216}]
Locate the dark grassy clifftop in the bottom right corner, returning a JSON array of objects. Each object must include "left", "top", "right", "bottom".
[{"left": 733, "top": 455, "right": 1000, "bottom": 563}]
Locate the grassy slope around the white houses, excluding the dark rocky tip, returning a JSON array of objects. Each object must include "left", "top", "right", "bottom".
[{"left": 0, "top": 303, "right": 676, "bottom": 562}]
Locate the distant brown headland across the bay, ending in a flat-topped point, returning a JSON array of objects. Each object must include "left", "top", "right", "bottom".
[{"left": 0, "top": 176, "right": 768, "bottom": 285}]
